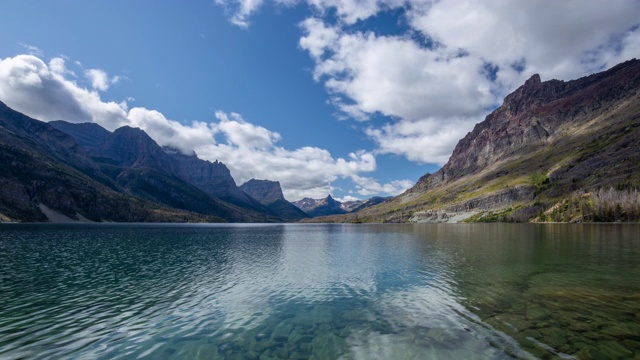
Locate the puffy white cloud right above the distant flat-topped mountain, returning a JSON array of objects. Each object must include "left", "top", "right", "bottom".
[{"left": 195, "top": 111, "right": 376, "bottom": 200}]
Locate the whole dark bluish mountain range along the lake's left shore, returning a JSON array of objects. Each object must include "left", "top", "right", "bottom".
[{"left": 0, "top": 103, "right": 305, "bottom": 222}]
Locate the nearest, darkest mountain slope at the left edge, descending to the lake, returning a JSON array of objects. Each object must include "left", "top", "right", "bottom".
[{"left": 0, "top": 102, "right": 224, "bottom": 222}]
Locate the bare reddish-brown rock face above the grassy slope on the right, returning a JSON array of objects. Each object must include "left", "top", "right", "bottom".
[{"left": 410, "top": 59, "right": 640, "bottom": 191}]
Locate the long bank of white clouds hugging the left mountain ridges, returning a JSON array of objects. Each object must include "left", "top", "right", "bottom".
[{"left": 0, "top": 55, "right": 393, "bottom": 200}]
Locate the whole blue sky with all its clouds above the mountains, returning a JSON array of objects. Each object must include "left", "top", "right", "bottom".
[{"left": 0, "top": 0, "right": 640, "bottom": 200}]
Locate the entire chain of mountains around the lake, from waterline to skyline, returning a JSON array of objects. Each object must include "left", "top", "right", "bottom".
[{"left": 0, "top": 59, "right": 640, "bottom": 223}]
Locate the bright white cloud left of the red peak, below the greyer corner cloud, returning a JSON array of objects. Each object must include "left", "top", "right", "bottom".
[{"left": 300, "top": 19, "right": 498, "bottom": 165}]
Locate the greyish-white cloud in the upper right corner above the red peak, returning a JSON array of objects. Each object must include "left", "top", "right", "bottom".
[{"left": 409, "top": 0, "right": 640, "bottom": 80}]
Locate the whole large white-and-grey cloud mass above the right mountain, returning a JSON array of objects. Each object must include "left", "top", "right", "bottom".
[{"left": 299, "top": 0, "right": 640, "bottom": 165}]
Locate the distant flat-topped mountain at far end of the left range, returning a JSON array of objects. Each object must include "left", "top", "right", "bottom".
[{"left": 240, "top": 179, "right": 309, "bottom": 221}]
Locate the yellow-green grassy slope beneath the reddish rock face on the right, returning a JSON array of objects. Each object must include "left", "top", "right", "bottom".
[{"left": 312, "top": 90, "right": 640, "bottom": 222}]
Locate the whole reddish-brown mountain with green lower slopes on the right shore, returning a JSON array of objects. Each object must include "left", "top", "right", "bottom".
[{"left": 318, "top": 59, "right": 640, "bottom": 222}]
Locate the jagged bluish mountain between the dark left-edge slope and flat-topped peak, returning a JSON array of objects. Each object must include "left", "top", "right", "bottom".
[{"left": 51, "top": 121, "right": 278, "bottom": 222}]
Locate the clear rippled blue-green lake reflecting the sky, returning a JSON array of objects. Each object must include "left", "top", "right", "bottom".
[{"left": 0, "top": 224, "right": 640, "bottom": 359}]
